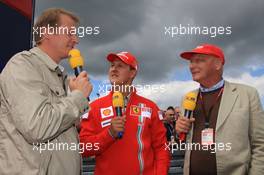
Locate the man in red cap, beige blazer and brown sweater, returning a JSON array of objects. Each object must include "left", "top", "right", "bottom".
[{"left": 176, "top": 44, "right": 264, "bottom": 175}]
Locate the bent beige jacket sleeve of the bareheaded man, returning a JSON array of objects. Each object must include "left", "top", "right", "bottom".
[{"left": 1, "top": 55, "right": 88, "bottom": 144}]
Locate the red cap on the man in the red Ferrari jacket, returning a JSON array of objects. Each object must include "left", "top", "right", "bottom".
[{"left": 106, "top": 52, "right": 138, "bottom": 70}]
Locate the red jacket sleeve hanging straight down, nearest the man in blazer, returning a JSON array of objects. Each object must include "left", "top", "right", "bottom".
[{"left": 151, "top": 106, "right": 170, "bottom": 175}]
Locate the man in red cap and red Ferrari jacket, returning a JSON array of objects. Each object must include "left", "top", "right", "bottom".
[{"left": 80, "top": 52, "right": 169, "bottom": 175}]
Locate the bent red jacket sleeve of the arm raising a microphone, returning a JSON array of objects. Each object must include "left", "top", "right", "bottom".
[{"left": 80, "top": 103, "right": 115, "bottom": 157}]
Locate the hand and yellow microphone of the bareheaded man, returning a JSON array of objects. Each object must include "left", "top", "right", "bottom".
[{"left": 69, "top": 49, "right": 93, "bottom": 101}]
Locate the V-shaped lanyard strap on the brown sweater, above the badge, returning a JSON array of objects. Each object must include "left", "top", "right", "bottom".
[{"left": 199, "top": 87, "right": 224, "bottom": 128}]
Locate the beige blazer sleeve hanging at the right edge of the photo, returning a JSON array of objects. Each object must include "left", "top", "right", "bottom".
[{"left": 249, "top": 89, "right": 264, "bottom": 175}]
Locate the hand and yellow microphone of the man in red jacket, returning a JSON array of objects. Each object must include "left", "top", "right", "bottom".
[{"left": 110, "top": 91, "right": 126, "bottom": 139}]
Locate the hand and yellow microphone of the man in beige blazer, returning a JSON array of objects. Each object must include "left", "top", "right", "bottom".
[{"left": 175, "top": 92, "right": 197, "bottom": 141}]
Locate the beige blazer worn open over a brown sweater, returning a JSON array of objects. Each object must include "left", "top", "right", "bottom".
[{"left": 184, "top": 81, "right": 264, "bottom": 175}]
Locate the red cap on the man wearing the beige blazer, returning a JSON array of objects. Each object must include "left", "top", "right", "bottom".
[{"left": 180, "top": 44, "right": 225, "bottom": 65}]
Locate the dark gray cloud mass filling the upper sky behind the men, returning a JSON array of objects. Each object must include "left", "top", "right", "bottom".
[{"left": 36, "top": 0, "right": 264, "bottom": 83}]
